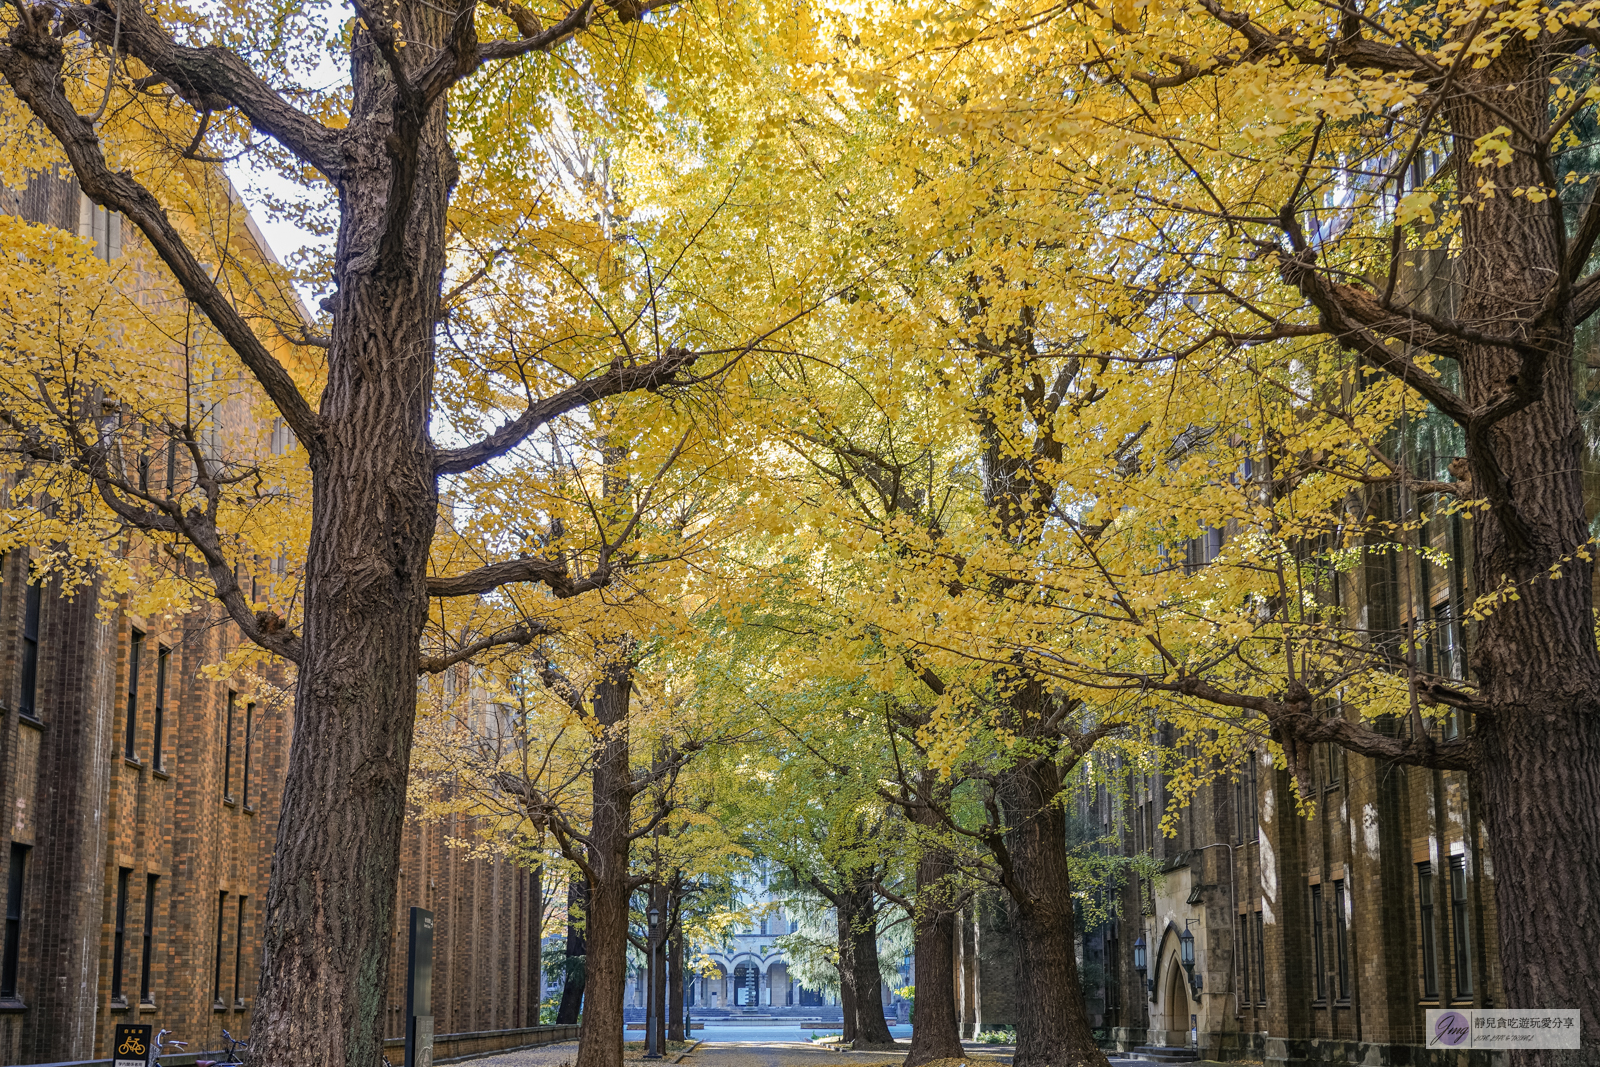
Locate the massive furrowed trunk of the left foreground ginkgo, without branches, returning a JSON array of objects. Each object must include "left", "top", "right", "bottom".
[{"left": 251, "top": 5, "right": 456, "bottom": 1067}]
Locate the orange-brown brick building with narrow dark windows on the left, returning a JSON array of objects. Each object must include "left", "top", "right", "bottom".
[{"left": 0, "top": 174, "right": 539, "bottom": 1064}]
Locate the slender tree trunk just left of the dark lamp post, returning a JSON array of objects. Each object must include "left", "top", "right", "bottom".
[{"left": 578, "top": 649, "right": 634, "bottom": 1067}]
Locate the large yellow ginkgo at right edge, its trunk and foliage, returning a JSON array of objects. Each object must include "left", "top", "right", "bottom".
[{"left": 771, "top": 0, "right": 1600, "bottom": 1059}]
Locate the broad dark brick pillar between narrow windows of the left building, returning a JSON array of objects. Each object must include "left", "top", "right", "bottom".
[{"left": 18, "top": 581, "right": 117, "bottom": 1062}]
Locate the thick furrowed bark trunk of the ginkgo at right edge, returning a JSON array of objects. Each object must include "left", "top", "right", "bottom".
[{"left": 1445, "top": 49, "right": 1600, "bottom": 1062}]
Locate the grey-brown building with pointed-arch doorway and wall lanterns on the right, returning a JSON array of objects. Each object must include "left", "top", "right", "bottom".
[{"left": 1078, "top": 476, "right": 1501, "bottom": 1064}]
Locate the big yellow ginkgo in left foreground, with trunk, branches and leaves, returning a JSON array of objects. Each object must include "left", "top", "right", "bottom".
[{"left": 0, "top": 0, "right": 811, "bottom": 1067}]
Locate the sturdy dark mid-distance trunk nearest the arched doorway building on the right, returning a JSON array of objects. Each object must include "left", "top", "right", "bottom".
[{"left": 1000, "top": 757, "right": 1107, "bottom": 1067}]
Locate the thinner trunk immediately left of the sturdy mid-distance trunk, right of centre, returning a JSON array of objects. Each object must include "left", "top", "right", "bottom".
[{"left": 906, "top": 773, "right": 966, "bottom": 1067}]
